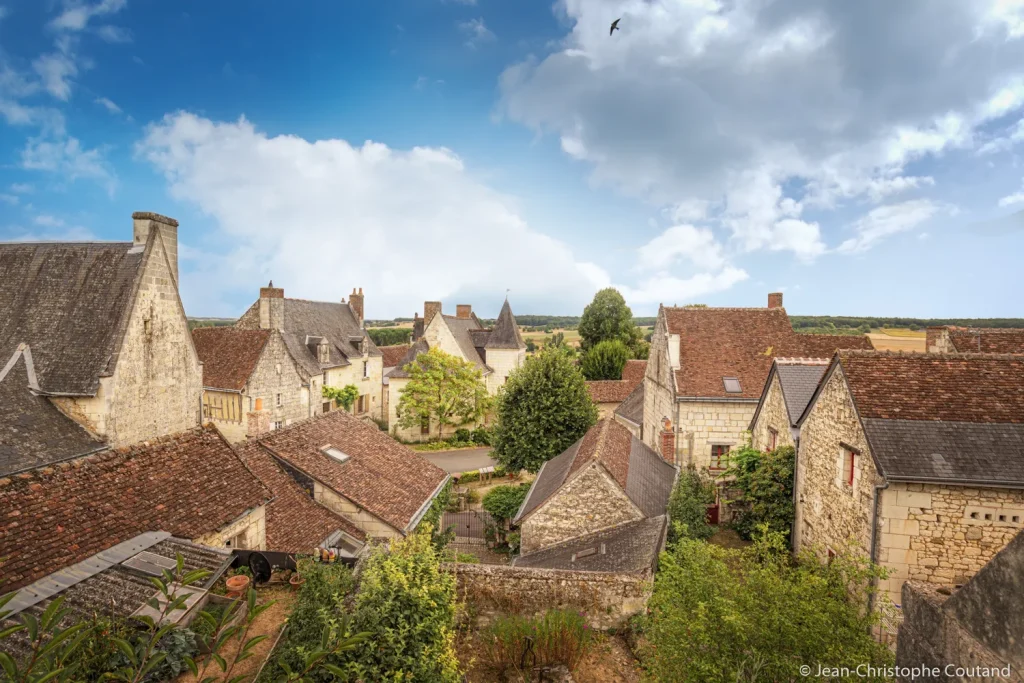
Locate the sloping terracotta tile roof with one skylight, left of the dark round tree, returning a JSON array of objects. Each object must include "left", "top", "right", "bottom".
[{"left": 253, "top": 411, "right": 447, "bottom": 531}]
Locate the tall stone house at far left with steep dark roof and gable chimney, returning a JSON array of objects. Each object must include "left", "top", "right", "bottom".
[{"left": 0, "top": 212, "right": 203, "bottom": 460}]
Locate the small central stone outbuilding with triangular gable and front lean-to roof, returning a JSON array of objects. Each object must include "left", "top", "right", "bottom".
[{"left": 514, "top": 419, "right": 678, "bottom": 571}]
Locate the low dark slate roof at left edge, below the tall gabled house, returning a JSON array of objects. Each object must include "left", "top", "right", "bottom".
[{"left": 0, "top": 346, "right": 105, "bottom": 476}]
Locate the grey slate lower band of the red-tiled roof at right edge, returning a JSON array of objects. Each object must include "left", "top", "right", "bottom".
[{"left": 861, "top": 418, "right": 1024, "bottom": 486}]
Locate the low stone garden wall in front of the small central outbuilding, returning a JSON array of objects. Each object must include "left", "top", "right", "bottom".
[{"left": 447, "top": 564, "right": 652, "bottom": 629}]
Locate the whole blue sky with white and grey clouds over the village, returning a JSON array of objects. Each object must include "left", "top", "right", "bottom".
[{"left": 0, "top": 0, "right": 1024, "bottom": 318}]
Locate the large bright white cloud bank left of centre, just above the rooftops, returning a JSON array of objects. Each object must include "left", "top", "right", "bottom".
[{"left": 137, "top": 113, "right": 609, "bottom": 317}]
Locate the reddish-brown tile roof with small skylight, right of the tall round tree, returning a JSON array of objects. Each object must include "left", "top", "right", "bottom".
[{"left": 664, "top": 307, "right": 870, "bottom": 400}]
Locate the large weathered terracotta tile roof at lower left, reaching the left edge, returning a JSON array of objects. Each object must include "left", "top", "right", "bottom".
[{"left": 0, "top": 426, "right": 270, "bottom": 590}]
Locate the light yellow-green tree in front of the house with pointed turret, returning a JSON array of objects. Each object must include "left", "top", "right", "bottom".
[{"left": 398, "top": 348, "right": 489, "bottom": 436}]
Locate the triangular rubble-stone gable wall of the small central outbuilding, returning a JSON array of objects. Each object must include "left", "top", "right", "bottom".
[{"left": 521, "top": 463, "right": 643, "bottom": 553}]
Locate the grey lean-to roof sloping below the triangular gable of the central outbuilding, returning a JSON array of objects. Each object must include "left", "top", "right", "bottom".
[{"left": 512, "top": 516, "right": 668, "bottom": 572}]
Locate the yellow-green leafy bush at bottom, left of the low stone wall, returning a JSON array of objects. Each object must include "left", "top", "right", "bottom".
[{"left": 350, "top": 531, "right": 461, "bottom": 683}]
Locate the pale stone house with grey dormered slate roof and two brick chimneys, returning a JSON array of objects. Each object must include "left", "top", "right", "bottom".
[{"left": 234, "top": 282, "right": 384, "bottom": 427}]
